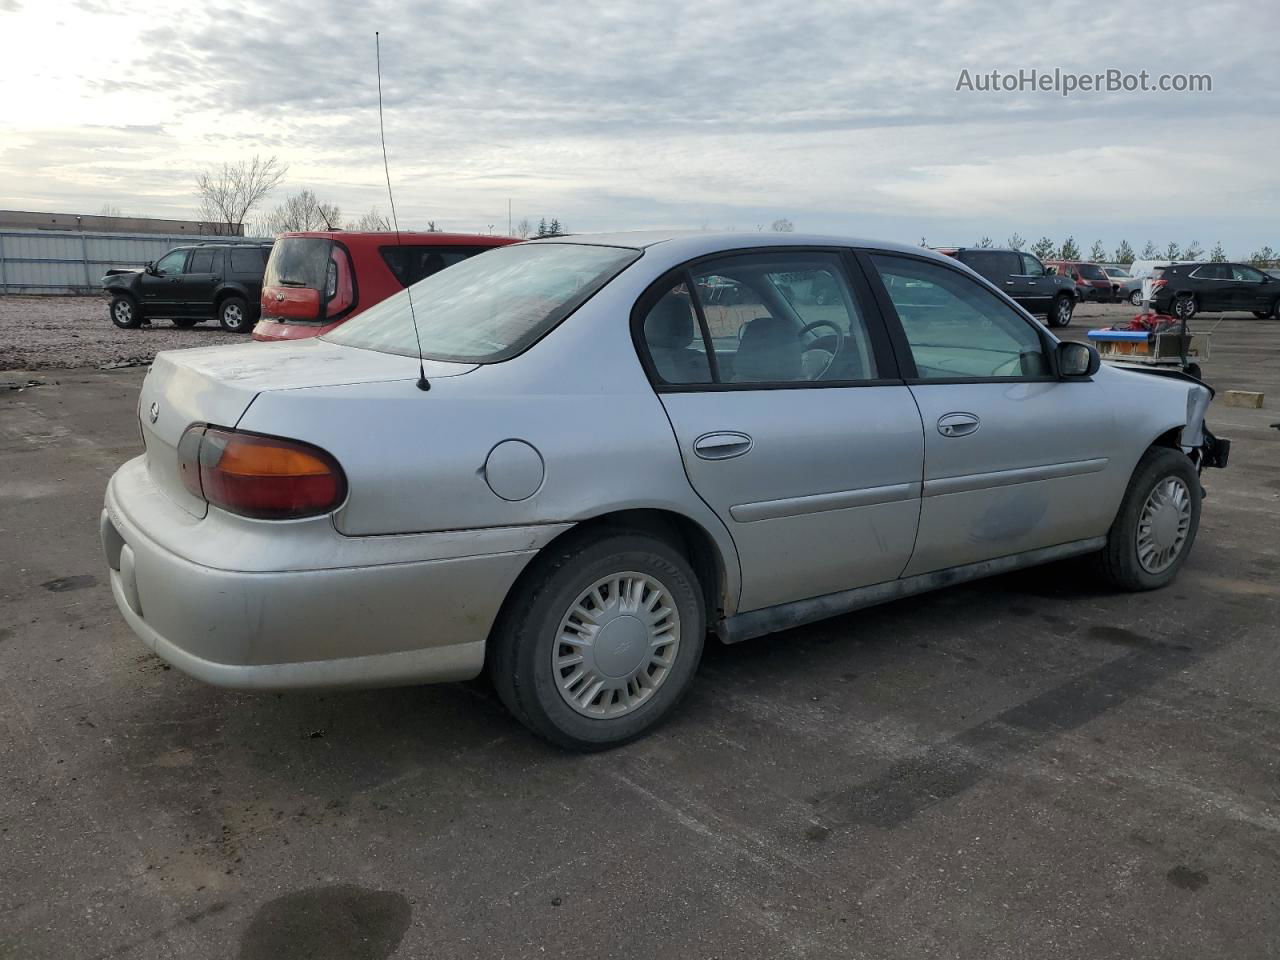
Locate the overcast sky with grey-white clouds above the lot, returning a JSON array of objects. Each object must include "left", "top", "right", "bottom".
[{"left": 0, "top": 0, "right": 1280, "bottom": 256}]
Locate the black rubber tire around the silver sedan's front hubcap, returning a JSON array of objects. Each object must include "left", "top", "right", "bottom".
[{"left": 1098, "top": 447, "right": 1201, "bottom": 591}]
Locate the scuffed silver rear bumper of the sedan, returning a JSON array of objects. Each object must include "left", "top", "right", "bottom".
[{"left": 101, "top": 457, "right": 567, "bottom": 690}]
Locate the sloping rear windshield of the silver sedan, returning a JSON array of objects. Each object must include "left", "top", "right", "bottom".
[{"left": 323, "top": 243, "right": 640, "bottom": 364}]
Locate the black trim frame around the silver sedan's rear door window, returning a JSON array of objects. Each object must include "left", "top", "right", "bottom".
[{"left": 631, "top": 244, "right": 904, "bottom": 393}]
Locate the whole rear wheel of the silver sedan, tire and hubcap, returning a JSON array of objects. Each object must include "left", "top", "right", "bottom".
[{"left": 489, "top": 532, "right": 707, "bottom": 750}]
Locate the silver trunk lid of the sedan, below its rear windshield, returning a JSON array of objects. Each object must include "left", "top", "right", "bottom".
[{"left": 138, "top": 339, "right": 476, "bottom": 517}]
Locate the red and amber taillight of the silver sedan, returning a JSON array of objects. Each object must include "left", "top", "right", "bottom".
[{"left": 178, "top": 424, "right": 347, "bottom": 520}]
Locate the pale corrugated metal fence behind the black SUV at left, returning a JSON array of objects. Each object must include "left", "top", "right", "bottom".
[{"left": 0, "top": 230, "right": 262, "bottom": 294}]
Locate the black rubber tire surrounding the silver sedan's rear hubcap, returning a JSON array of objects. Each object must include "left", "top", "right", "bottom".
[{"left": 489, "top": 530, "right": 707, "bottom": 751}]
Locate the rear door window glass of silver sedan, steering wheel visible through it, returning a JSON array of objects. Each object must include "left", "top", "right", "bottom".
[{"left": 641, "top": 251, "right": 877, "bottom": 385}]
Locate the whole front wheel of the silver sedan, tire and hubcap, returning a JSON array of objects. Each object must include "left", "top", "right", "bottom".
[{"left": 1100, "top": 447, "right": 1201, "bottom": 590}]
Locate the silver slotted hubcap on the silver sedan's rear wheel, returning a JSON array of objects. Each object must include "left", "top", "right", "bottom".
[{"left": 552, "top": 572, "right": 680, "bottom": 717}]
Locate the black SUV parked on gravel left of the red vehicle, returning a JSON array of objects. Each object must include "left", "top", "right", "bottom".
[{"left": 102, "top": 241, "right": 271, "bottom": 333}]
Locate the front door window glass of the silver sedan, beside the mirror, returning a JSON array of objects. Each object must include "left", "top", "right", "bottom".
[{"left": 872, "top": 253, "right": 1050, "bottom": 380}]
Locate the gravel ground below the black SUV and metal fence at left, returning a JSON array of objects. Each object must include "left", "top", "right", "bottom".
[{"left": 0, "top": 297, "right": 246, "bottom": 370}]
